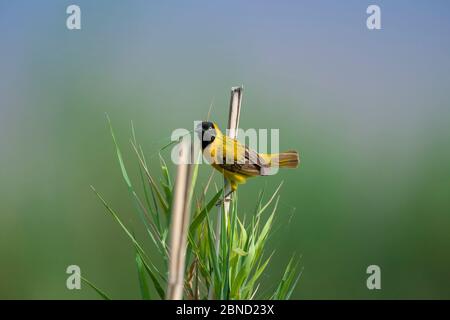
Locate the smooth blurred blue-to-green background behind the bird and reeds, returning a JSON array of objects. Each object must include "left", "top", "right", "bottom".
[{"left": 0, "top": 0, "right": 450, "bottom": 299}]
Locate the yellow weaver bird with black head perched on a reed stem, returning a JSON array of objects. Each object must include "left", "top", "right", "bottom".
[{"left": 195, "top": 121, "right": 299, "bottom": 196}]
